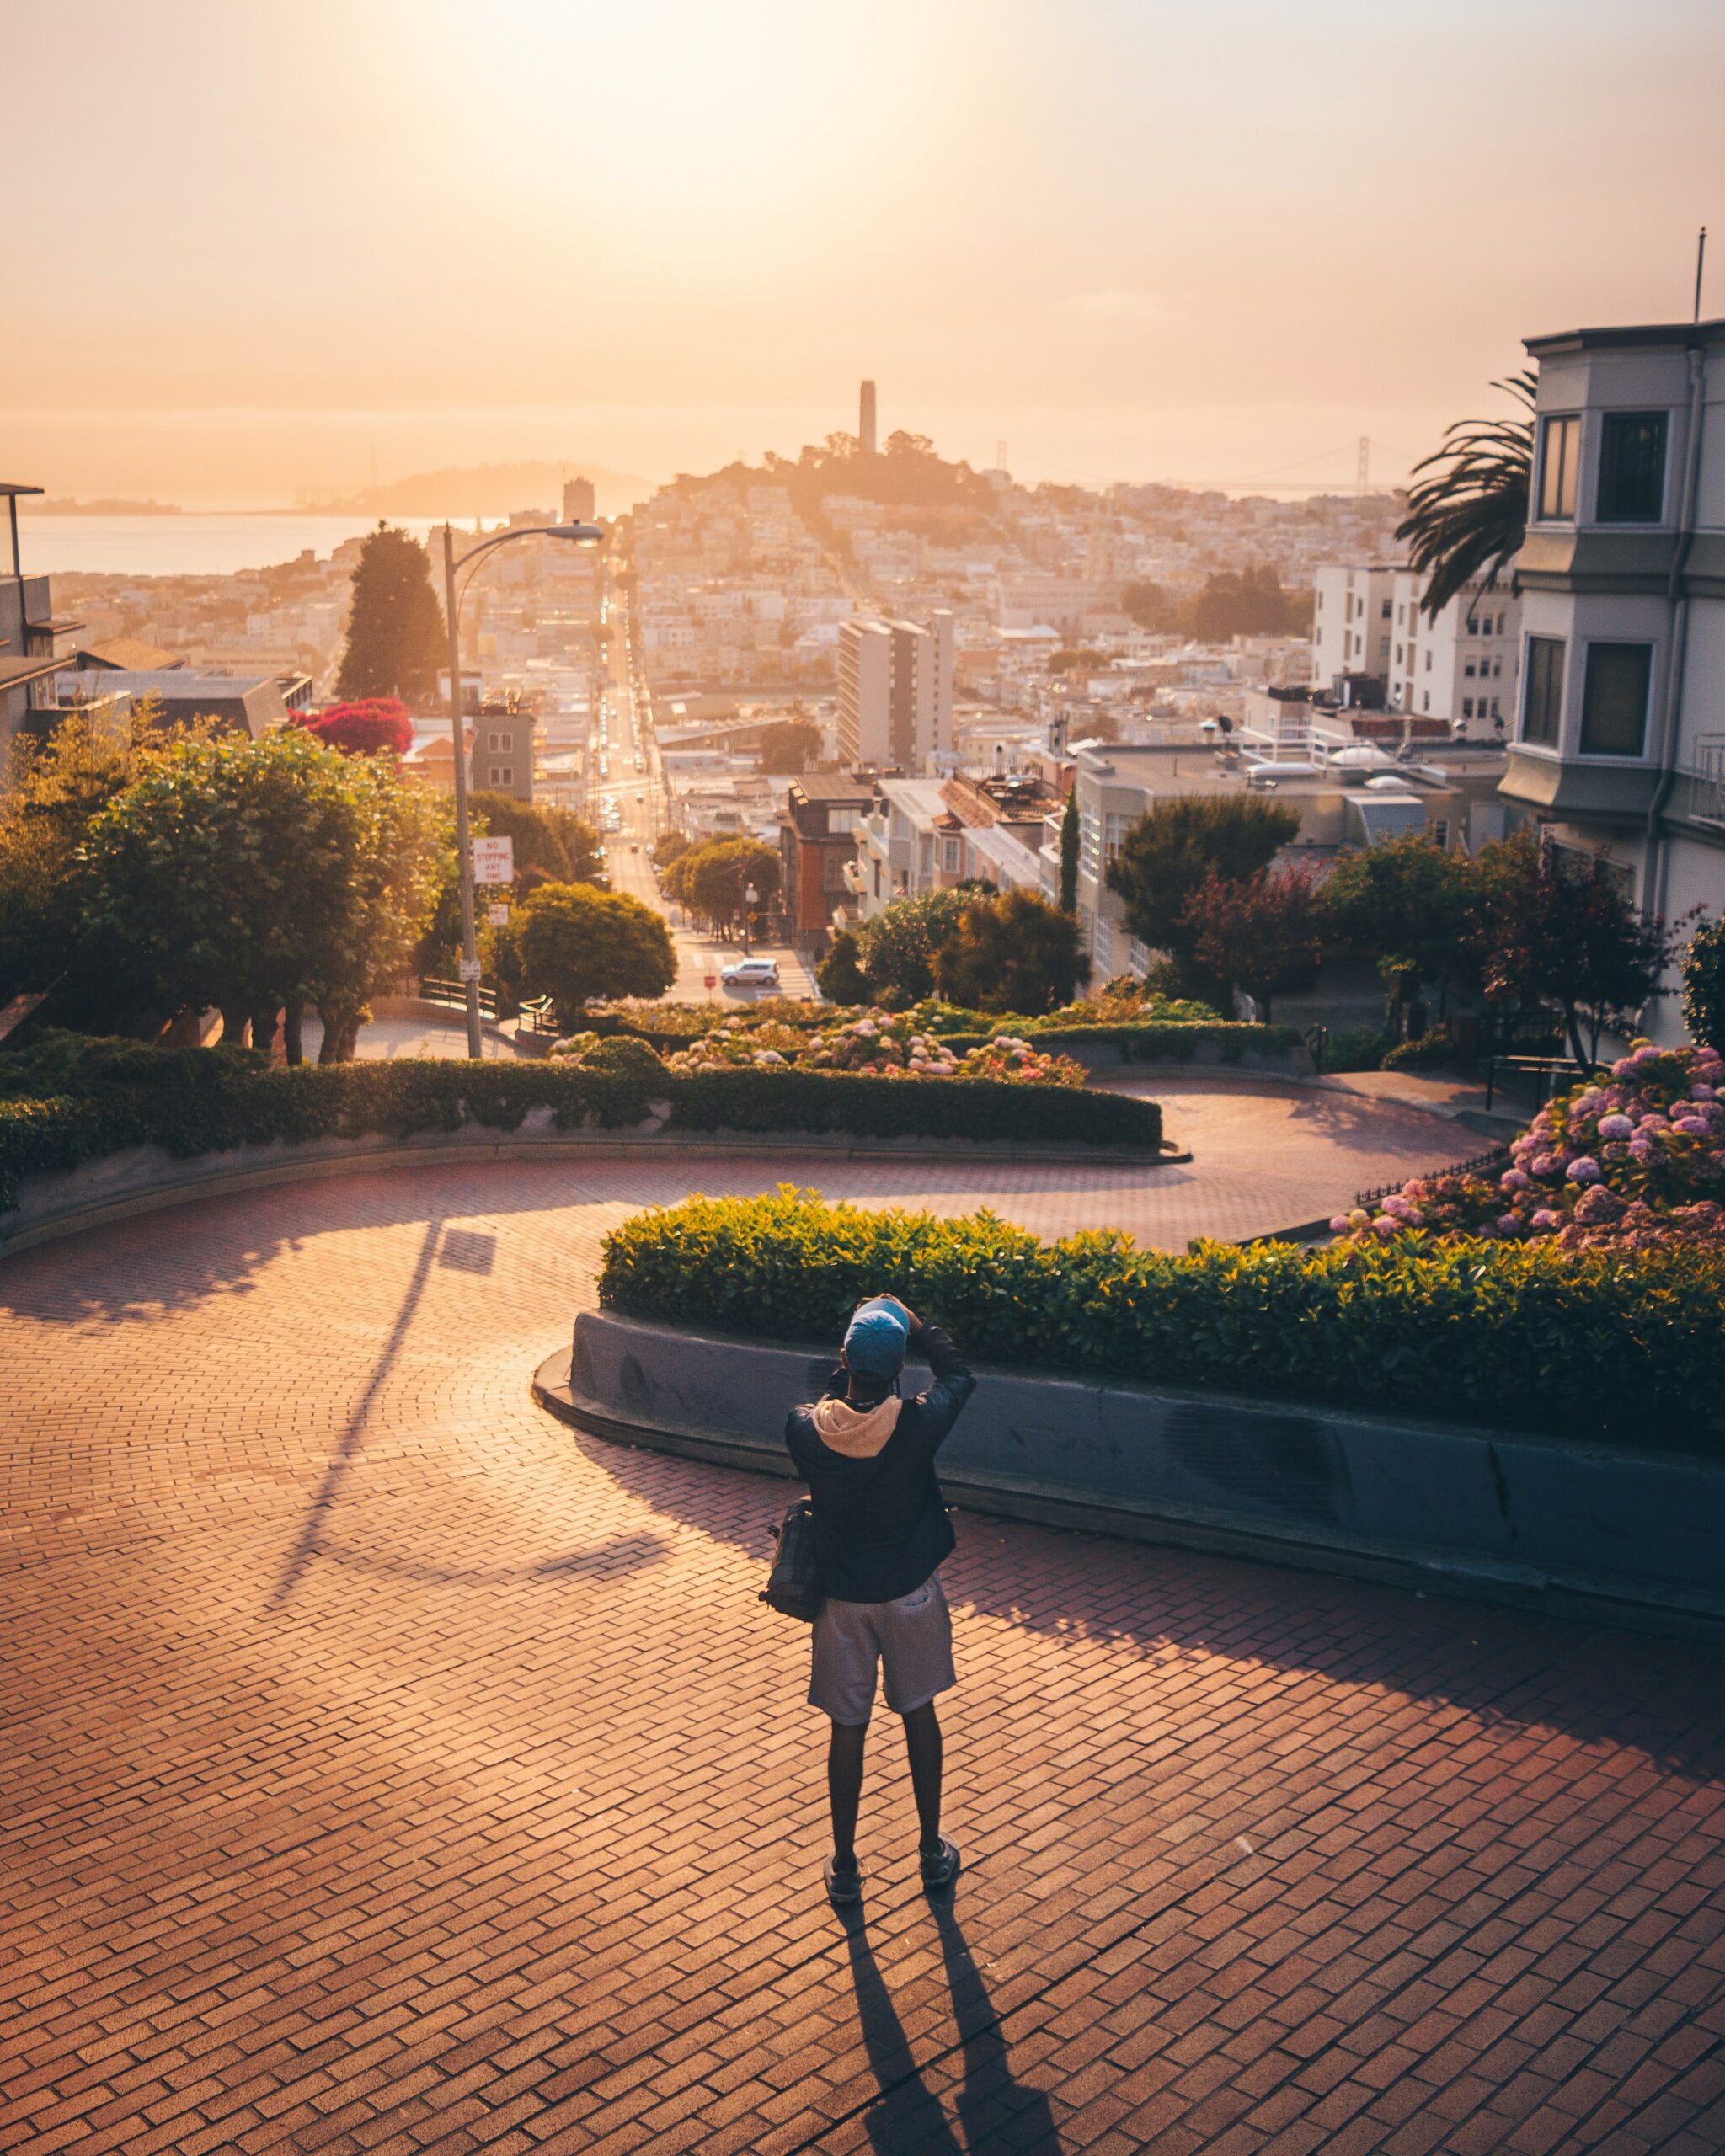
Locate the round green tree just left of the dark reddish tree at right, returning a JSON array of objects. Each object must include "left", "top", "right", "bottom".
[{"left": 1317, "top": 832, "right": 1479, "bottom": 1039}]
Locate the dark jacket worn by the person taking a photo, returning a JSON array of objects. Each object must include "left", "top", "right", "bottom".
[{"left": 785, "top": 1326, "right": 977, "bottom": 1602}]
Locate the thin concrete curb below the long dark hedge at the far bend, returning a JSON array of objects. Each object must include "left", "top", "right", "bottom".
[{"left": 0, "top": 1123, "right": 1193, "bottom": 1259}]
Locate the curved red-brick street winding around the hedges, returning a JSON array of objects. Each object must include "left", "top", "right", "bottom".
[{"left": 0, "top": 1082, "right": 1725, "bottom": 2156}]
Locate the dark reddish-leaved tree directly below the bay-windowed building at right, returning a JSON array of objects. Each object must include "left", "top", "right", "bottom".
[{"left": 1472, "top": 830, "right": 1678, "bottom": 1070}]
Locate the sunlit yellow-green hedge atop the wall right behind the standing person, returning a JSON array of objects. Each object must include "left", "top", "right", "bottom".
[{"left": 600, "top": 1188, "right": 1725, "bottom": 1455}]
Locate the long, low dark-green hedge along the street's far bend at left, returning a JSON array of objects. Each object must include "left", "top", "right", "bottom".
[{"left": 0, "top": 1041, "right": 1162, "bottom": 1209}]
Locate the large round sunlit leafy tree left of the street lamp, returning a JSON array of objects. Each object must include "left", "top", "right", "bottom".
[{"left": 84, "top": 728, "right": 448, "bottom": 1061}]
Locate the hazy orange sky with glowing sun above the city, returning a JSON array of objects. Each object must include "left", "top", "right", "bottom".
[{"left": 0, "top": 0, "right": 1725, "bottom": 500}]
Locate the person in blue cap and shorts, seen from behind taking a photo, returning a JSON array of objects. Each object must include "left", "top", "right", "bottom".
[{"left": 785, "top": 1296, "right": 977, "bottom": 1906}]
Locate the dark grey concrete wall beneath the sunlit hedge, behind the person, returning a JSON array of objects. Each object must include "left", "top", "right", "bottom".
[{"left": 532, "top": 1310, "right": 1725, "bottom": 1639}]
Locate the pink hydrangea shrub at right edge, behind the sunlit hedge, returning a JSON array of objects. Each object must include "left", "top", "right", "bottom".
[{"left": 1331, "top": 1041, "right": 1725, "bottom": 1251}]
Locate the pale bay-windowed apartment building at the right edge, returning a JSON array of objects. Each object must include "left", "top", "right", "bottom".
[{"left": 1503, "top": 321, "right": 1725, "bottom": 1039}]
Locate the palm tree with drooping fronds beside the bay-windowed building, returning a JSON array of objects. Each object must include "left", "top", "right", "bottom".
[{"left": 1395, "top": 373, "right": 1537, "bottom": 621}]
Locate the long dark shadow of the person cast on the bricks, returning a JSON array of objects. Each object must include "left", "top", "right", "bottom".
[{"left": 846, "top": 1899, "right": 1063, "bottom": 2156}]
